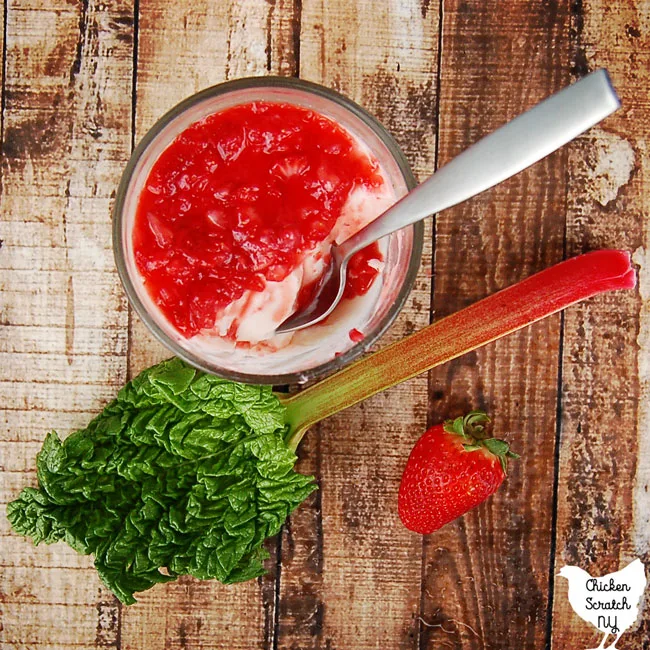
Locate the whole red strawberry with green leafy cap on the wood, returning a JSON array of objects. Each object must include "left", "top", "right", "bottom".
[{"left": 398, "top": 411, "right": 519, "bottom": 534}]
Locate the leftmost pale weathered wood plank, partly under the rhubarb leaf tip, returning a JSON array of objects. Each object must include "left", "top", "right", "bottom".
[{"left": 0, "top": 0, "right": 133, "bottom": 648}]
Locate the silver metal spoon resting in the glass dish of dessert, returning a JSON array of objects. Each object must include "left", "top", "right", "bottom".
[{"left": 276, "top": 70, "right": 621, "bottom": 334}]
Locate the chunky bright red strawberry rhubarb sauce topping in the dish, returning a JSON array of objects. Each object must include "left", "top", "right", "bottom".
[{"left": 133, "top": 102, "right": 384, "bottom": 338}]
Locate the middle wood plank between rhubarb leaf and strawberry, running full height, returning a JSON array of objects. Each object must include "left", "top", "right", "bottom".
[{"left": 278, "top": 0, "right": 438, "bottom": 648}]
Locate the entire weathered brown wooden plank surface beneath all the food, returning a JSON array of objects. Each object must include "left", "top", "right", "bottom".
[{"left": 0, "top": 0, "right": 650, "bottom": 650}]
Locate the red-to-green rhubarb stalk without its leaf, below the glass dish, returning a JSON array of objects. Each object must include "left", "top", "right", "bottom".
[{"left": 284, "top": 250, "right": 636, "bottom": 449}]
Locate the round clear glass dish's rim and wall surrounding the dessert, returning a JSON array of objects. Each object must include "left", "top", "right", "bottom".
[{"left": 113, "top": 77, "right": 424, "bottom": 385}]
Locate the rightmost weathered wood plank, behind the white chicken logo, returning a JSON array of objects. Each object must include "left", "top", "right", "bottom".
[{"left": 552, "top": 0, "right": 650, "bottom": 648}]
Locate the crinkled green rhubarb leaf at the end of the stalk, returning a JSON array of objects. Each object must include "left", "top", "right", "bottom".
[{"left": 7, "top": 359, "right": 316, "bottom": 604}]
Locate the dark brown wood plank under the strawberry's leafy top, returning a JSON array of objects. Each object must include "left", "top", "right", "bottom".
[{"left": 421, "top": 0, "right": 568, "bottom": 649}]
